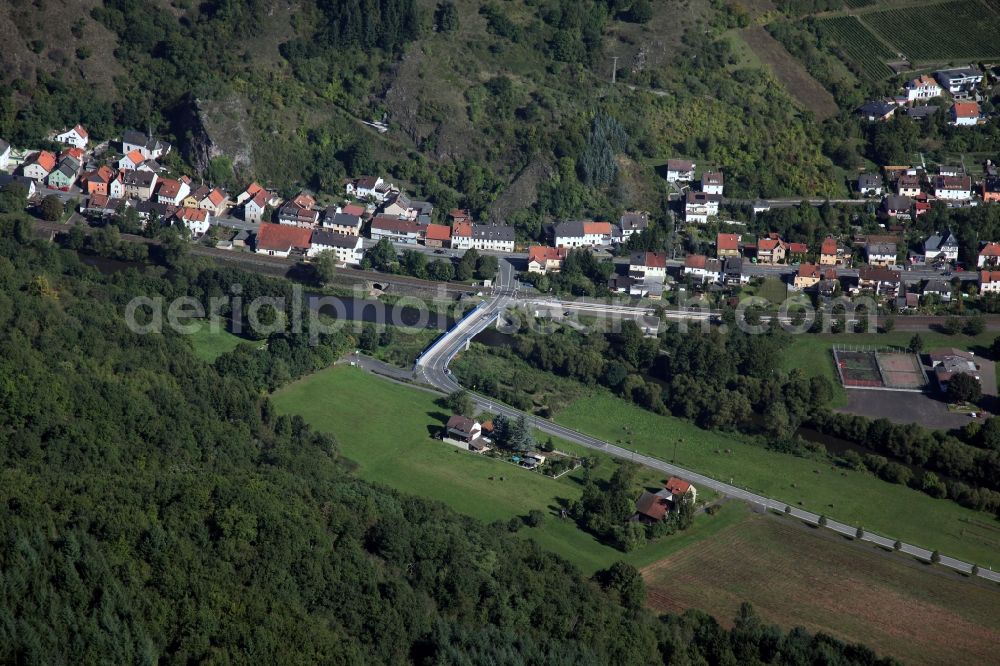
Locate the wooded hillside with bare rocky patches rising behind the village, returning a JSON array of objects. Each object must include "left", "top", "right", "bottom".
[{"left": 0, "top": 0, "right": 840, "bottom": 228}]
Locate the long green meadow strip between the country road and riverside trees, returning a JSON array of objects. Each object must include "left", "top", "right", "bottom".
[{"left": 555, "top": 393, "right": 1000, "bottom": 567}]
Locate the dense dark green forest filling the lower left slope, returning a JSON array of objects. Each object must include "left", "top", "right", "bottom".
[{"left": 0, "top": 217, "right": 904, "bottom": 664}]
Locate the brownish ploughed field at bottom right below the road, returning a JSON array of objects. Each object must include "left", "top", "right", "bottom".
[{"left": 643, "top": 508, "right": 1000, "bottom": 664}]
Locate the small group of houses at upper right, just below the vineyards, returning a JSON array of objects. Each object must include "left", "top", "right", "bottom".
[{"left": 858, "top": 65, "right": 987, "bottom": 127}]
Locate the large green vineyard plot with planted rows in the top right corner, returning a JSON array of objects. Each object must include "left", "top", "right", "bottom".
[{"left": 863, "top": 0, "right": 1000, "bottom": 61}]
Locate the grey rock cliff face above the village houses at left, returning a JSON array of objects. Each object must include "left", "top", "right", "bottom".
[{"left": 175, "top": 93, "right": 254, "bottom": 176}]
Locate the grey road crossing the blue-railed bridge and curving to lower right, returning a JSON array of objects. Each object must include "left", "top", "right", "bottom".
[{"left": 414, "top": 261, "right": 1000, "bottom": 582}]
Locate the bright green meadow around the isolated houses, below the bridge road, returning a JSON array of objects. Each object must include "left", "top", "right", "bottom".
[{"left": 273, "top": 366, "right": 740, "bottom": 573}]
